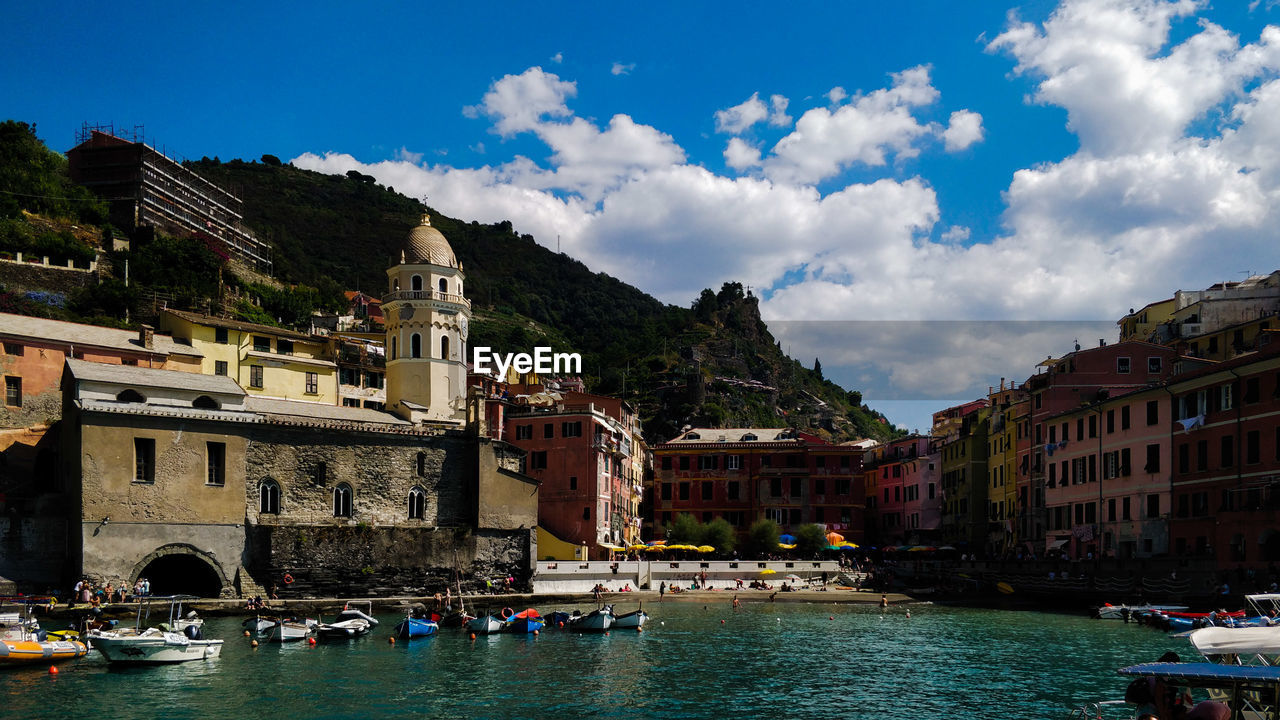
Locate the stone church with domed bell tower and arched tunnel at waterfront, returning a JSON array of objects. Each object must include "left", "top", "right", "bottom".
[{"left": 59, "top": 217, "right": 538, "bottom": 597}]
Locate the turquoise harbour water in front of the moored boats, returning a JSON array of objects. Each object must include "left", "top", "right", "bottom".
[{"left": 0, "top": 602, "right": 1192, "bottom": 720}]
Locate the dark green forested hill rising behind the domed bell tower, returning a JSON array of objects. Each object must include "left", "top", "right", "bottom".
[{"left": 191, "top": 156, "right": 895, "bottom": 441}]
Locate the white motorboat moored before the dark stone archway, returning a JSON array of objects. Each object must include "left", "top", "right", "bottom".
[{"left": 87, "top": 594, "right": 223, "bottom": 665}]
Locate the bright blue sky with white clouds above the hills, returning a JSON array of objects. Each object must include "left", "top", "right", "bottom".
[{"left": 0, "top": 0, "right": 1280, "bottom": 429}]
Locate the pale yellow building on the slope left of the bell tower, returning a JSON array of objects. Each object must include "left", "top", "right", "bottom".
[{"left": 159, "top": 310, "right": 338, "bottom": 405}]
